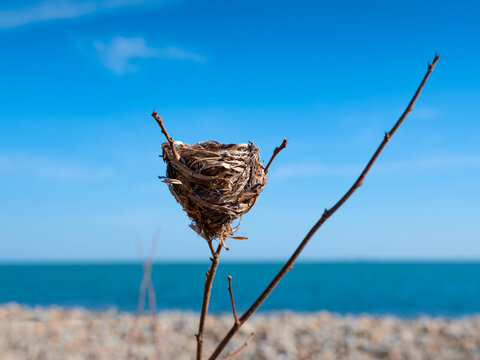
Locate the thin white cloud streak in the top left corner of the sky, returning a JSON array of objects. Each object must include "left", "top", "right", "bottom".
[{"left": 0, "top": 0, "right": 174, "bottom": 28}]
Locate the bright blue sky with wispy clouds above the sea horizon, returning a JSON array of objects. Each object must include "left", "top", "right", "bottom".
[{"left": 0, "top": 0, "right": 480, "bottom": 261}]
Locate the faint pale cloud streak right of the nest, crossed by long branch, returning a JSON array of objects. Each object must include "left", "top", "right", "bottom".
[{"left": 272, "top": 154, "right": 480, "bottom": 179}]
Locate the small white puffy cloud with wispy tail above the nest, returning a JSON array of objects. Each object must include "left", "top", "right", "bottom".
[{"left": 94, "top": 36, "right": 205, "bottom": 74}]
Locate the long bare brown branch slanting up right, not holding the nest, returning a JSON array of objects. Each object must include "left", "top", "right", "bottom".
[{"left": 209, "top": 55, "right": 439, "bottom": 360}]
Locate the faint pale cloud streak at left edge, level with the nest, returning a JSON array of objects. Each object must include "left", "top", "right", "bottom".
[{"left": 0, "top": 153, "right": 112, "bottom": 181}]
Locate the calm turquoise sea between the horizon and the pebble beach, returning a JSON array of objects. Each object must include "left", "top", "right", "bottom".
[{"left": 0, "top": 263, "right": 480, "bottom": 316}]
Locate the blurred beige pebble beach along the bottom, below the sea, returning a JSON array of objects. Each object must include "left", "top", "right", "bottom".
[{"left": 0, "top": 304, "right": 480, "bottom": 360}]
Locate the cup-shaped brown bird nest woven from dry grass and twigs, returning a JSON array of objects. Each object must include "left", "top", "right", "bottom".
[{"left": 162, "top": 141, "right": 267, "bottom": 241}]
